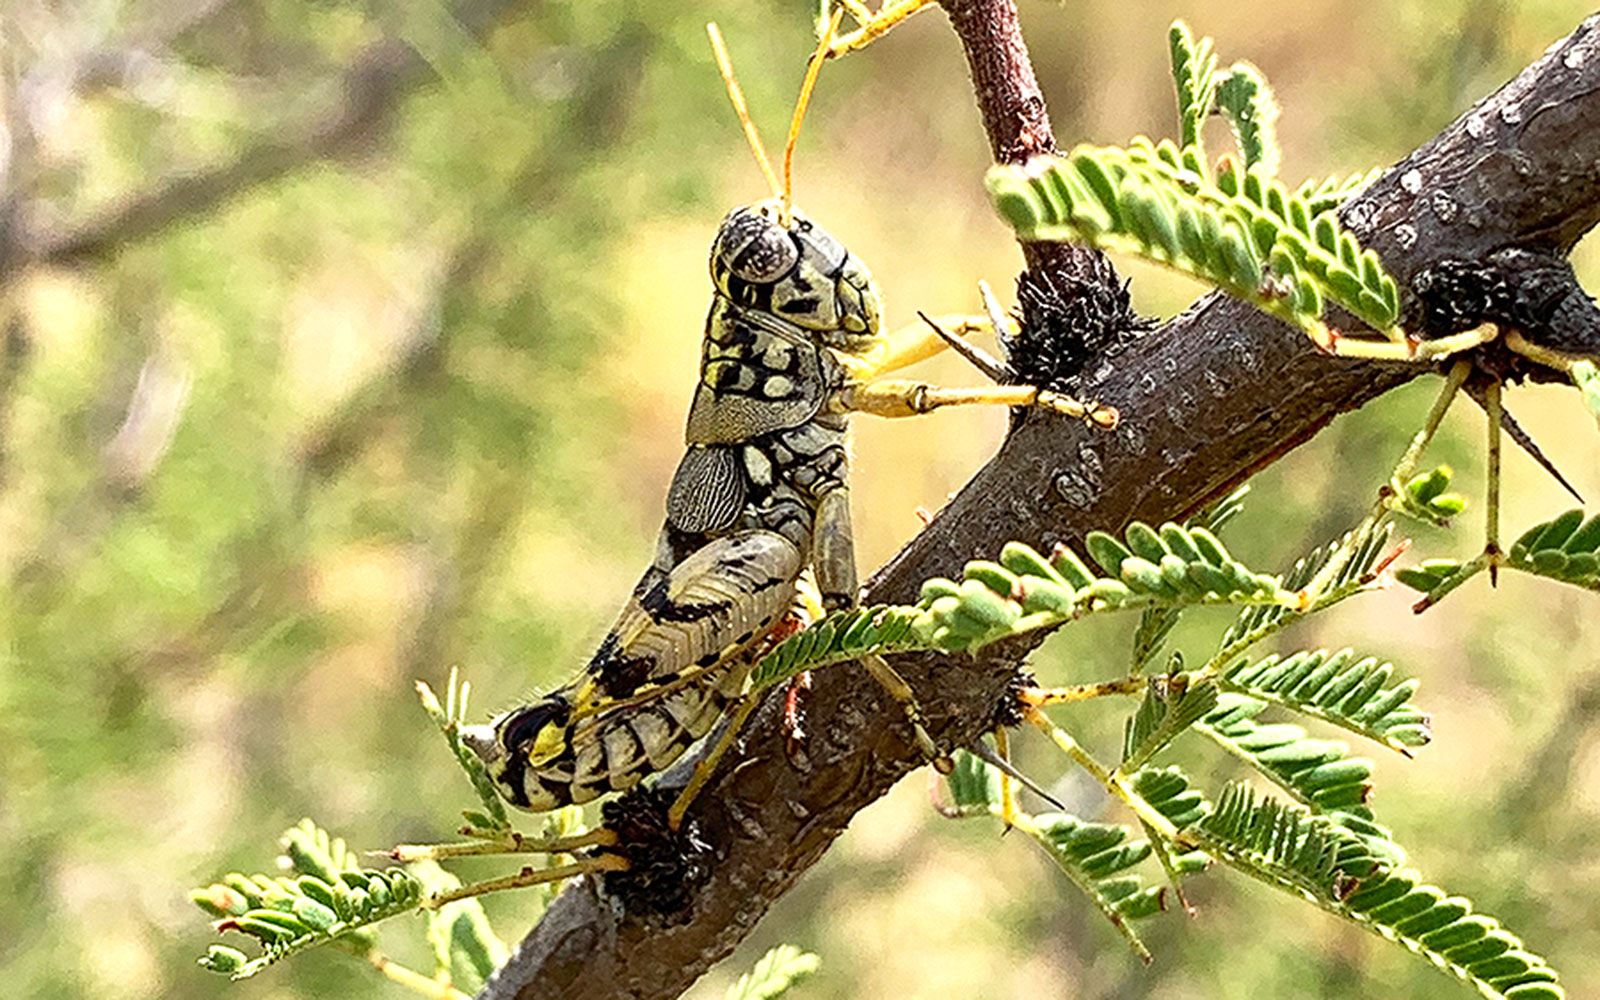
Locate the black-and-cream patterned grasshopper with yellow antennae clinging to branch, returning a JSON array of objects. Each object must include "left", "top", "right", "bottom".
[{"left": 462, "top": 16, "right": 1117, "bottom": 826}]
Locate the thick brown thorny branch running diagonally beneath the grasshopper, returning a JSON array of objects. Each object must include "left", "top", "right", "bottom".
[{"left": 482, "top": 9, "right": 1600, "bottom": 1000}]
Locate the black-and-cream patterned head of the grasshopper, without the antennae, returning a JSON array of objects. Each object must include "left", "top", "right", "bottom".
[{"left": 710, "top": 198, "right": 882, "bottom": 354}]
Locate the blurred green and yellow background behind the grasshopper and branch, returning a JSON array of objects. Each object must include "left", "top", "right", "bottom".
[{"left": 0, "top": 0, "right": 1600, "bottom": 1000}]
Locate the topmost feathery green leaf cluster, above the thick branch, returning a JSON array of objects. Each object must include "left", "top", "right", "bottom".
[{"left": 987, "top": 22, "right": 1403, "bottom": 346}]
